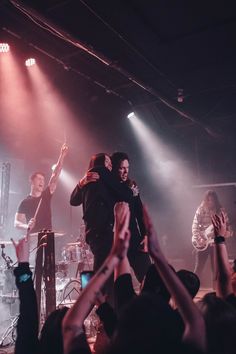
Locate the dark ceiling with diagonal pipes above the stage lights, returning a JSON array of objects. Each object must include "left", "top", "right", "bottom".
[{"left": 0, "top": 0, "right": 236, "bottom": 180}]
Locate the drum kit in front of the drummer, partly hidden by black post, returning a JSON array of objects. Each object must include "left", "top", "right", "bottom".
[{"left": 0, "top": 232, "right": 97, "bottom": 346}]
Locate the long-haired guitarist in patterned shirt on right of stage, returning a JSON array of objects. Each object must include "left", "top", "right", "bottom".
[{"left": 192, "top": 190, "right": 232, "bottom": 279}]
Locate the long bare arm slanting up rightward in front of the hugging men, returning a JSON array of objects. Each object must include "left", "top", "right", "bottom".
[{"left": 62, "top": 202, "right": 129, "bottom": 354}]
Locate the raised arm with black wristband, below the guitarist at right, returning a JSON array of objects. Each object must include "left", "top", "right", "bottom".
[{"left": 212, "top": 213, "right": 233, "bottom": 299}]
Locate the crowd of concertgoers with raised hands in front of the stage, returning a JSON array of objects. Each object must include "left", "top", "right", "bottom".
[{"left": 11, "top": 202, "right": 236, "bottom": 354}]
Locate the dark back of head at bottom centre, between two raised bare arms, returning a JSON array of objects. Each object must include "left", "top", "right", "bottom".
[{"left": 108, "top": 293, "right": 183, "bottom": 354}]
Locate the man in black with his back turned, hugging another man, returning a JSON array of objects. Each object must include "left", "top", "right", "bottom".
[{"left": 70, "top": 154, "right": 132, "bottom": 271}]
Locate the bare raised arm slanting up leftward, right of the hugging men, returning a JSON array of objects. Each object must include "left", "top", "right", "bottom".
[{"left": 144, "top": 210, "right": 206, "bottom": 351}]
